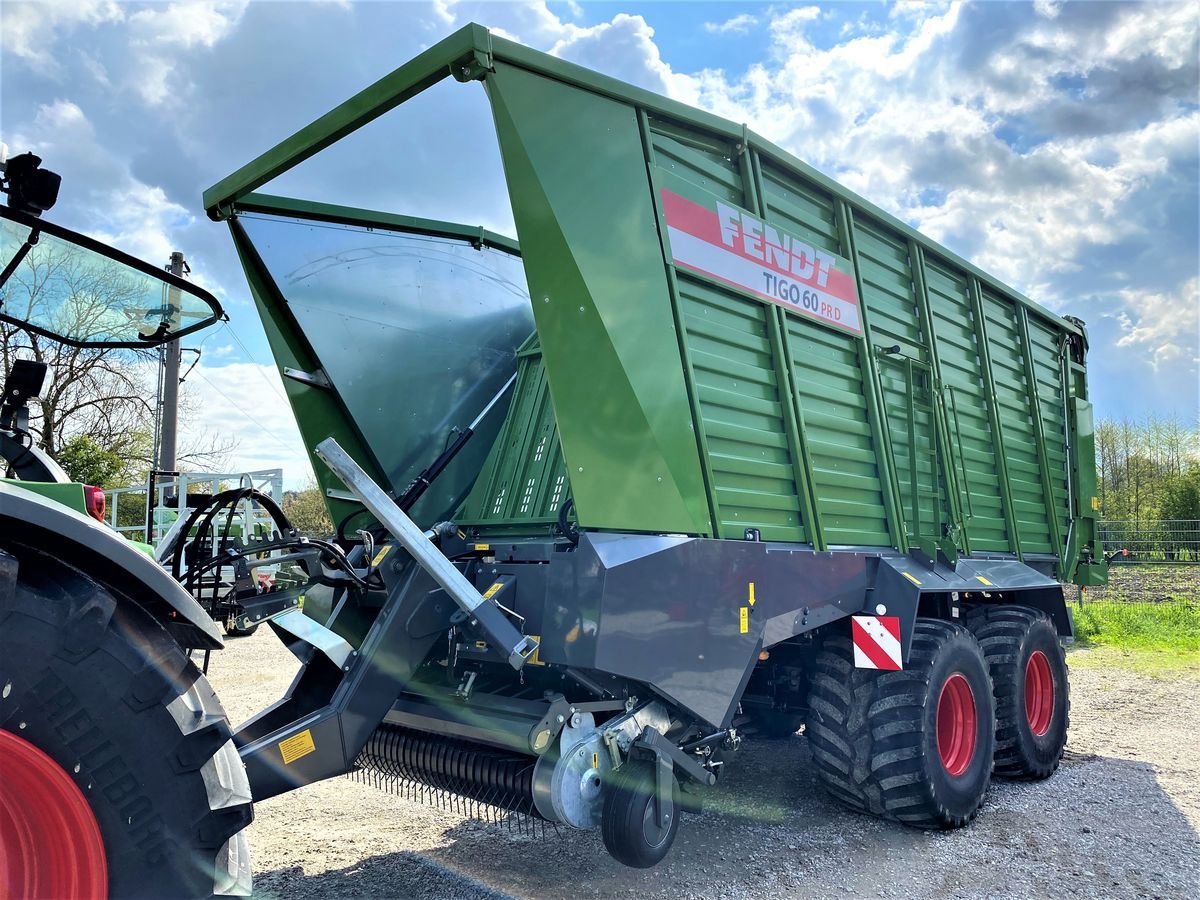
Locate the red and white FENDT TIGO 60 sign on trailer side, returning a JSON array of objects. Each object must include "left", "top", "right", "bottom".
[{"left": 662, "top": 188, "right": 863, "bottom": 335}]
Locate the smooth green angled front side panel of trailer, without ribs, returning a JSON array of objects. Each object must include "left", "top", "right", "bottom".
[{"left": 485, "top": 62, "right": 714, "bottom": 535}]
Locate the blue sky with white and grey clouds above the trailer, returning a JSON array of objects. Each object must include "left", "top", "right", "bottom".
[{"left": 0, "top": 0, "right": 1200, "bottom": 485}]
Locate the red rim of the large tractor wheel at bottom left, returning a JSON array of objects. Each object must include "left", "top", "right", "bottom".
[{"left": 0, "top": 731, "right": 108, "bottom": 900}]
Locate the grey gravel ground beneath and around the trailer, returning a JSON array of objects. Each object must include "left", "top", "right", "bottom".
[{"left": 210, "top": 629, "right": 1200, "bottom": 900}]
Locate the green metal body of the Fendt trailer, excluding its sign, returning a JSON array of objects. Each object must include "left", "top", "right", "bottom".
[{"left": 205, "top": 26, "right": 1103, "bottom": 581}]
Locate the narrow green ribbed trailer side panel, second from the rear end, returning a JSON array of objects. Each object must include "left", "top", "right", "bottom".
[{"left": 983, "top": 290, "right": 1056, "bottom": 553}]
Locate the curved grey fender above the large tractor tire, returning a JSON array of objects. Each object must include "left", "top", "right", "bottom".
[{"left": 0, "top": 482, "right": 224, "bottom": 649}]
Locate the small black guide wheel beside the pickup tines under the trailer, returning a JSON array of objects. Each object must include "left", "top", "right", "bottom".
[{"left": 600, "top": 762, "right": 679, "bottom": 869}]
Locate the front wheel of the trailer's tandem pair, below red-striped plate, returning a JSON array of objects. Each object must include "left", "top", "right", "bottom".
[{"left": 805, "top": 619, "right": 995, "bottom": 829}]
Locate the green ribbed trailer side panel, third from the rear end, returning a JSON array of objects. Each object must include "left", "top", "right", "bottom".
[{"left": 925, "top": 259, "right": 1010, "bottom": 552}]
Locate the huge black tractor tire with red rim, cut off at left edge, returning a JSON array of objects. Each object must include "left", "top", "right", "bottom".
[{"left": 0, "top": 554, "right": 253, "bottom": 898}]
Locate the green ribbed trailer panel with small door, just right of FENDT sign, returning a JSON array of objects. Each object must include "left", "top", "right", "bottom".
[{"left": 854, "top": 216, "right": 949, "bottom": 542}]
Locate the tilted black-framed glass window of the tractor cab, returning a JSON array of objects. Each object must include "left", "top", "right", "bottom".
[{"left": 0, "top": 208, "right": 222, "bottom": 347}]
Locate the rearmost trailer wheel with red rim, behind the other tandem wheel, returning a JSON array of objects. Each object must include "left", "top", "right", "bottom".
[{"left": 966, "top": 605, "right": 1070, "bottom": 780}]
